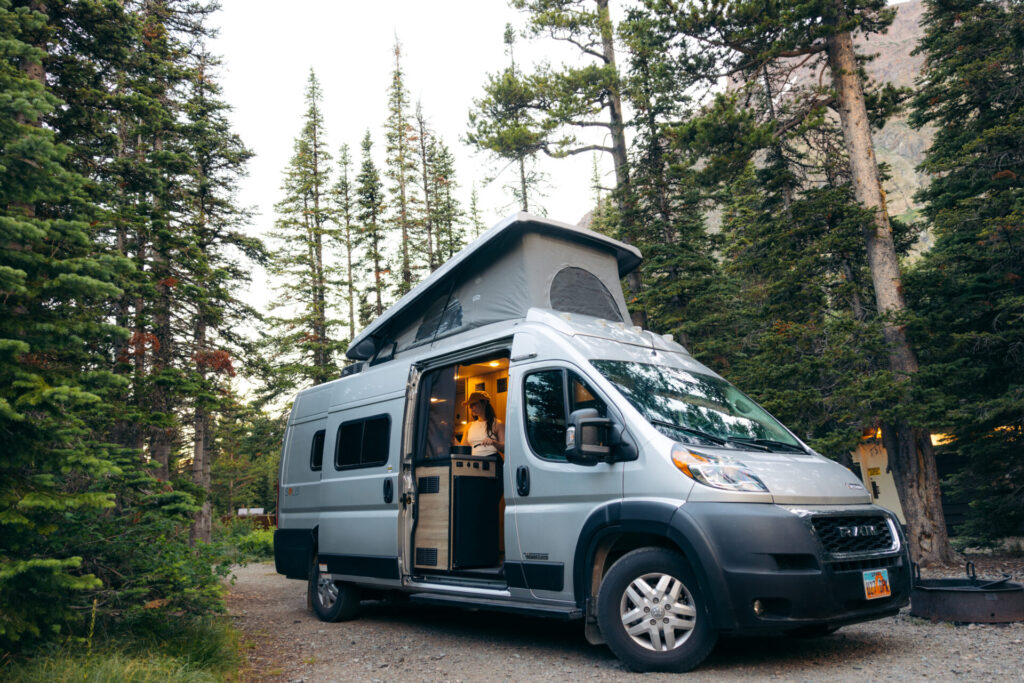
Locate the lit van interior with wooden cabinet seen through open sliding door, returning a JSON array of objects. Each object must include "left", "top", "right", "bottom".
[{"left": 412, "top": 352, "right": 509, "bottom": 581}]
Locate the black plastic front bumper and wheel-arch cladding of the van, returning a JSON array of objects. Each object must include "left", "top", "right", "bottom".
[{"left": 669, "top": 503, "right": 911, "bottom": 634}]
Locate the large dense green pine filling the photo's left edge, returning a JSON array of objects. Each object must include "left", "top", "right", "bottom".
[{"left": 0, "top": 0, "right": 122, "bottom": 651}]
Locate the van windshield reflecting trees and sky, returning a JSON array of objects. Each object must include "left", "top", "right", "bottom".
[{"left": 591, "top": 360, "right": 805, "bottom": 453}]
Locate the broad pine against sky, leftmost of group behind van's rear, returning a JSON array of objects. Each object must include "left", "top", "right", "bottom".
[{"left": 269, "top": 70, "right": 345, "bottom": 391}]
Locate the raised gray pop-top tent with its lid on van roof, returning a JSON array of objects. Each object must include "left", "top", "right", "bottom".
[{"left": 347, "top": 213, "right": 641, "bottom": 360}]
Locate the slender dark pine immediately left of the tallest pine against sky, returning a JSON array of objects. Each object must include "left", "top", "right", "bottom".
[{"left": 355, "top": 130, "right": 388, "bottom": 326}]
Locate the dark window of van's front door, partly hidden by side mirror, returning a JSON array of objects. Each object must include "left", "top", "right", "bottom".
[{"left": 523, "top": 370, "right": 606, "bottom": 461}]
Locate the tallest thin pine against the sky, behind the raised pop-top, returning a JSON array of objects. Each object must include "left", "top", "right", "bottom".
[{"left": 384, "top": 40, "right": 421, "bottom": 297}]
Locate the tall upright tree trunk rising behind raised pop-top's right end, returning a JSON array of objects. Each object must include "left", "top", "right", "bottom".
[{"left": 597, "top": 0, "right": 647, "bottom": 327}]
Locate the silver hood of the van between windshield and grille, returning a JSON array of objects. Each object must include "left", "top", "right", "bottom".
[{"left": 729, "top": 452, "right": 871, "bottom": 505}]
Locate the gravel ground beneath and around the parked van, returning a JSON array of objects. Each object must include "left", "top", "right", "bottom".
[{"left": 228, "top": 556, "right": 1024, "bottom": 683}]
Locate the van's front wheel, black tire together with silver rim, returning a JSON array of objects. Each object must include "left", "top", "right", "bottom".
[{"left": 597, "top": 548, "right": 718, "bottom": 673}]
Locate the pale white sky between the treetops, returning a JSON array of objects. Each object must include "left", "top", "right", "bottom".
[{"left": 211, "top": 0, "right": 611, "bottom": 307}]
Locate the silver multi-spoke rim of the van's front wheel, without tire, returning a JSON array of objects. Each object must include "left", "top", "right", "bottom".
[{"left": 618, "top": 572, "right": 697, "bottom": 652}]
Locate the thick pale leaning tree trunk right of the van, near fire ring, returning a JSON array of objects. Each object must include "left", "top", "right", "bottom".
[{"left": 827, "top": 25, "right": 955, "bottom": 565}]
